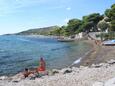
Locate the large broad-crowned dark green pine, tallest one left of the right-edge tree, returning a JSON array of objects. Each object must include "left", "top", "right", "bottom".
[{"left": 78, "top": 13, "right": 103, "bottom": 33}]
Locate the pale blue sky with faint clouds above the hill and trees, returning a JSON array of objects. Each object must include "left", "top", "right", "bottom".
[{"left": 0, "top": 0, "right": 115, "bottom": 34}]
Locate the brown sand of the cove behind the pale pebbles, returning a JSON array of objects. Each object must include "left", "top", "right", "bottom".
[{"left": 79, "top": 40, "right": 115, "bottom": 66}]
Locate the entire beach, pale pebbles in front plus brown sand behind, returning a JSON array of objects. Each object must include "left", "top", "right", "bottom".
[{"left": 0, "top": 41, "right": 115, "bottom": 86}]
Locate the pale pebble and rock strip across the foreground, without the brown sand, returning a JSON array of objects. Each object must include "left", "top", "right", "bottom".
[{"left": 0, "top": 60, "right": 115, "bottom": 86}]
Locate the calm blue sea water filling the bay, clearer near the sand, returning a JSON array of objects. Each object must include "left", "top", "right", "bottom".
[{"left": 0, "top": 36, "right": 90, "bottom": 75}]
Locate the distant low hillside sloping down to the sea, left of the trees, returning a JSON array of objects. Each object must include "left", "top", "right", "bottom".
[{"left": 16, "top": 26, "right": 60, "bottom": 35}]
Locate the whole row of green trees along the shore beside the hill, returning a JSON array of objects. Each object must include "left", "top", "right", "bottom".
[{"left": 51, "top": 4, "right": 115, "bottom": 36}]
